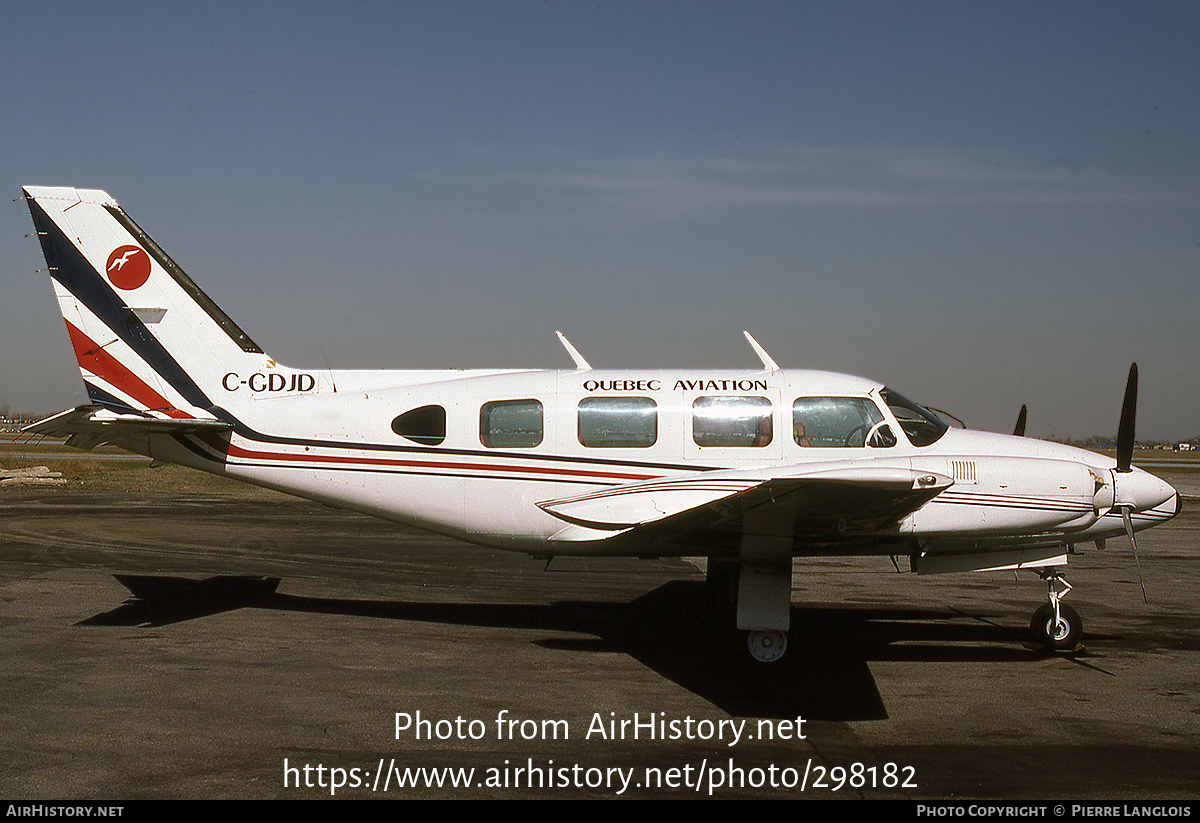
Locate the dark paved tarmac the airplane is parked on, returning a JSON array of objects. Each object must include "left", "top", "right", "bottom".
[{"left": 0, "top": 487, "right": 1200, "bottom": 800}]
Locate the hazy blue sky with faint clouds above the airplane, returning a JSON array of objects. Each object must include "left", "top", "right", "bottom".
[{"left": 0, "top": 1, "right": 1200, "bottom": 438}]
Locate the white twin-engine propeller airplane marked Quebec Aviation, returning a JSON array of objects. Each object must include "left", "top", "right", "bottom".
[{"left": 24, "top": 187, "right": 1178, "bottom": 661}]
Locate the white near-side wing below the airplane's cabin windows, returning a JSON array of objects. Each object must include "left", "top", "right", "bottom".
[{"left": 538, "top": 462, "right": 954, "bottom": 543}]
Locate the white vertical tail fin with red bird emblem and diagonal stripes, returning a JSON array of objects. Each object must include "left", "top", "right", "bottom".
[{"left": 24, "top": 186, "right": 276, "bottom": 419}]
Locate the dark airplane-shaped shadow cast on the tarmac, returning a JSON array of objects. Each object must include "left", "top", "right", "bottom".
[{"left": 77, "top": 575, "right": 1060, "bottom": 721}]
